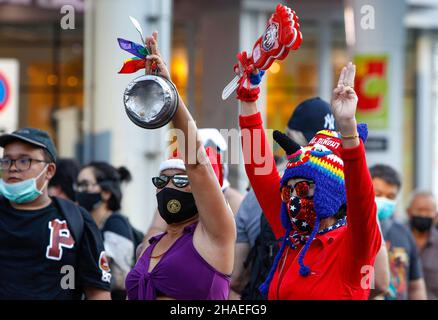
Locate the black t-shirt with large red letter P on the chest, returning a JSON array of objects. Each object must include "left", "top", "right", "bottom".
[{"left": 0, "top": 200, "right": 111, "bottom": 300}]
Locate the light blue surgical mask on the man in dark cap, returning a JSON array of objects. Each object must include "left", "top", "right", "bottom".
[{"left": 0, "top": 165, "right": 48, "bottom": 204}]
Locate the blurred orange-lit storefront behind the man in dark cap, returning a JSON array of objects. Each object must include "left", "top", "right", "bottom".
[{"left": 0, "top": 1, "right": 84, "bottom": 156}]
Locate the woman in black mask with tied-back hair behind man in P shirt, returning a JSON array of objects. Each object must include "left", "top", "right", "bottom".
[{"left": 75, "top": 162, "right": 135, "bottom": 300}]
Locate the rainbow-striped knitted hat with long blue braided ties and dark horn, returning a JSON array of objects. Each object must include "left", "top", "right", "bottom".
[{"left": 260, "top": 124, "right": 368, "bottom": 293}]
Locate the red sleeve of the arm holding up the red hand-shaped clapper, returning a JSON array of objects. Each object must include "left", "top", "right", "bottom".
[{"left": 239, "top": 112, "right": 284, "bottom": 239}]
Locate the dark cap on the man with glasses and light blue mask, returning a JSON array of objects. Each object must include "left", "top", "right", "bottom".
[{"left": 0, "top": 128, "right": 56, "bottom": 162}]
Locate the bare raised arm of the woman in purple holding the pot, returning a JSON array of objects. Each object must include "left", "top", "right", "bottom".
[{"left": 146, "top": 32, "right": 236, "bottom": 247}]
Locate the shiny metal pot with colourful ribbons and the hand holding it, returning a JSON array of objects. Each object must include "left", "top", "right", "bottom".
[{"left": 119, "top": 19, "right": 179, "bottom": 129}]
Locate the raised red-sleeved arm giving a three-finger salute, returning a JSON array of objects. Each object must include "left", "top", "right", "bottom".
[{"left": 332, "top": 62, "right": 382, "bottom": 283}]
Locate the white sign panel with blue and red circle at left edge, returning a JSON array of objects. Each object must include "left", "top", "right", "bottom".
[{"left": 0, "top": 59, "right": 20, "bottom": 133}]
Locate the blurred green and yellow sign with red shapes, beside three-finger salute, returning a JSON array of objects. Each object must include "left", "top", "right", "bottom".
[{"left": 354, "top": 54, "right": 389, "bottom": 129}]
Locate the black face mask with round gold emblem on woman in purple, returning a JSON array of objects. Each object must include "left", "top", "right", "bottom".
[{"left": 157, "top": 188, "right": 198, "bottom": 224}]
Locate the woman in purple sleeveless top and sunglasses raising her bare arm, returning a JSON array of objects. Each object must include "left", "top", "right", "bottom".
[{"left": 126, "top": 32, "right": 236, "bottom": 300}]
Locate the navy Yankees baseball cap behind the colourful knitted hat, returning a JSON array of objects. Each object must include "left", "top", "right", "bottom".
[{"left": 287, "top": 97, "right": 336, "bottom": 141}]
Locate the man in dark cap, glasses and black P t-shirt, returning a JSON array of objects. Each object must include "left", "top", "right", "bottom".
[{"left": 0, "top": 128, "right": 111, "bottom": 299}]
